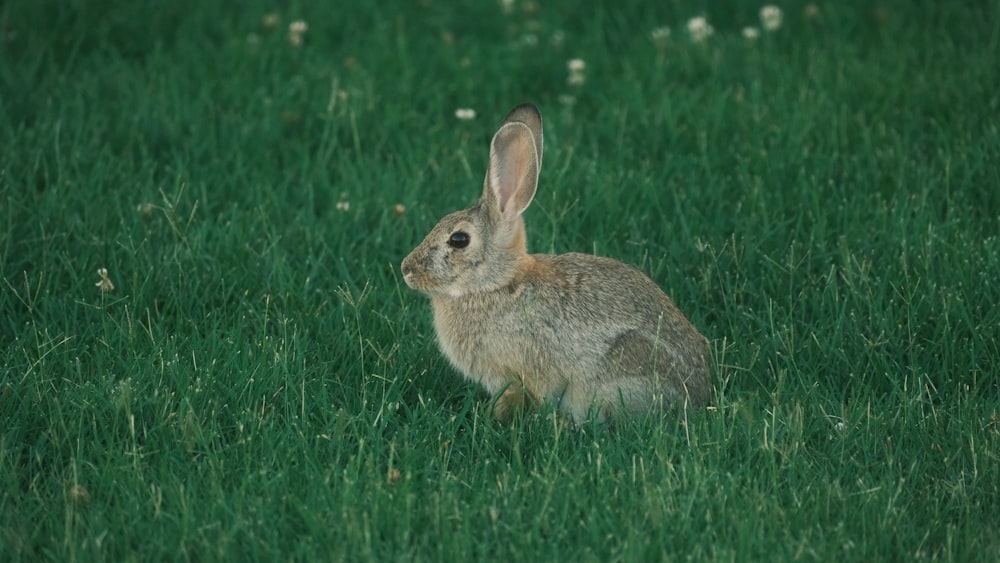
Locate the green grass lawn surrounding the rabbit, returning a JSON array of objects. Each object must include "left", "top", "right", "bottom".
[{"left": 0, "top": 0, "right": 1000, "bottom": 562}]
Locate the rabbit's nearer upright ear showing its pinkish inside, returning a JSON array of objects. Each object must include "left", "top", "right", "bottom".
[{"left": 483, "top": 111, "right": 542, "bottom": 220}]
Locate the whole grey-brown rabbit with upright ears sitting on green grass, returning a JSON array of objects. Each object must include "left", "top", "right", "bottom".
[{"left": 400, "top": 104, "right": 711, "bottom": 424}]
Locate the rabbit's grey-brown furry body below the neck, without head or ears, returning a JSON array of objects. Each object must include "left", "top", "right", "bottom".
[{"left": 431, "top": 253, "right": 708, "bottom": 420}]
